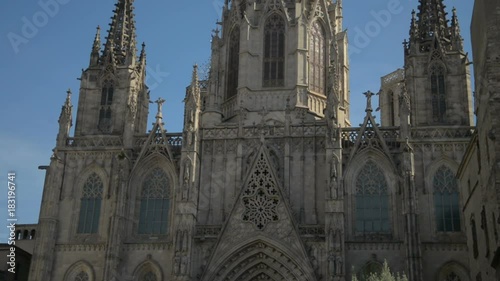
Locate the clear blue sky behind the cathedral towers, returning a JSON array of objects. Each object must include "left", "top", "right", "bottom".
[{"left": 0, "top": 0, "right": 473, "bottom": 241}]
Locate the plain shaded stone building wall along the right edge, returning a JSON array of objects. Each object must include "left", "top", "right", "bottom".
[{"left": 458, "top": 1, "right": 500, "bottom": 280}]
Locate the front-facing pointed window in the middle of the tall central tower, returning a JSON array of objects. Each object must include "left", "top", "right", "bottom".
[{"left": 263, "top": 13, "right": 285, "bottom": 87}]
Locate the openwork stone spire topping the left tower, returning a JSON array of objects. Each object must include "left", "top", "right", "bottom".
[{"left": 104, "top": 0, "right": 137, "bottom": 65}]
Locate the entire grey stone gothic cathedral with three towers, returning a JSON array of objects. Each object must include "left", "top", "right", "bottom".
[{"left": 30, "top": 0, "right": 473, "bottom": 281}]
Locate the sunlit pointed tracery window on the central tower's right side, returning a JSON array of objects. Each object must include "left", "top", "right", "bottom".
[{"left": 309, "top": 21, "right": 326, "bottom": 95}]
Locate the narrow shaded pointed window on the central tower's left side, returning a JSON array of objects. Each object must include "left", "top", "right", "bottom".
[{"left": 227, "top": 26, "right": 240, "bottom": 98}]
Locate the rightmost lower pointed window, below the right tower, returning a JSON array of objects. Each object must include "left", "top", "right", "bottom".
[{"left": 433, "top": 165, "right": 460, "bottom": 232}]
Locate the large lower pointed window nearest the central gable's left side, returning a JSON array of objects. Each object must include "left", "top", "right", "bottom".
[{"left": 138, "top": 168, "right": 170, "bottom": 234}]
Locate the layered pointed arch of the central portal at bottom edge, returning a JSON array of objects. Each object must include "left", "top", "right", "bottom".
[{"left": 208, "top": 240, "right": 312, "bottom": 281}]
